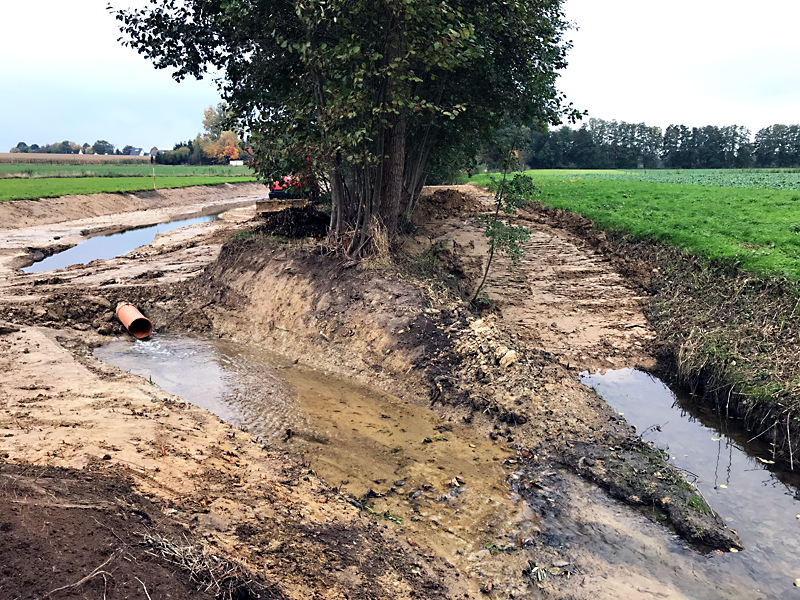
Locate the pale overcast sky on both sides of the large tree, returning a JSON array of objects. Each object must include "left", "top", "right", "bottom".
[{"left": 0, "top": 0, "right": 800, "bottom": 151}]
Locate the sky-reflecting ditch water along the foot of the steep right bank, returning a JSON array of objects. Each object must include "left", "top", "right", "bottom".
[{"left": 582, "top": 369, "right": 800, "bottom": 598}]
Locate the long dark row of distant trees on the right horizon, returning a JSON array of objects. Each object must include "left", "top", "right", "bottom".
[{"left": 478, "top": 119, "right": 800, "bottom": 169}]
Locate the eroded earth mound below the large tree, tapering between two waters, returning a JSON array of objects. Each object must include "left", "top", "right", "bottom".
[{"left": 143, "top": 232, "right": 740, "bottom": 549}]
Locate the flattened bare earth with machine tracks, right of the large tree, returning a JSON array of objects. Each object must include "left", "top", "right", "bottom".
[{"left": 424, "top": 185, "right": 655, "bottom": 370}]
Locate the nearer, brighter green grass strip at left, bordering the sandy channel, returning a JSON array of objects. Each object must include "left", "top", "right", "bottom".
[{"left": 0, "top": 176, "right": 256, "bottom": 202}]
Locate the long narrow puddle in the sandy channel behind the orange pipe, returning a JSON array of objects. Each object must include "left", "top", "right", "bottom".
[{"left": 22, "top": 213, "right": 219, "bottom": 273}]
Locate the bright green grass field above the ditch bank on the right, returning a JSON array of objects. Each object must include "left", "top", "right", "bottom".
[{"left": 470, "top": 171, "right": 800, "bottom": 280}]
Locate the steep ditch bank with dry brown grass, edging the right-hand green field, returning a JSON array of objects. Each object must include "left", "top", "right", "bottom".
[{"left": 520, "top": 203, "right": 800, "bottom": 467}]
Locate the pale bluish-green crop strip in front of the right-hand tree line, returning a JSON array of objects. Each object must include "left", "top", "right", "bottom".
[{"left": 556, "top": 169, "right": 800, "bottom": 190}]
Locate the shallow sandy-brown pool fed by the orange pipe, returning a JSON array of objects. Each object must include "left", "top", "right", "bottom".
[{"left": 94, "top": 335, "right": 524, "bottom": 558}]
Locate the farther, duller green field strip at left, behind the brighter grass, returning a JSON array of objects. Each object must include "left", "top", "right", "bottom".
[{"left": 0, "top": 163, "right": 253, "bottom": 179}]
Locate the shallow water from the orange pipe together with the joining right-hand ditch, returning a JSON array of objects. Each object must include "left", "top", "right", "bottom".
[{"left": 94, "top": 334, "right": 800, "bottom": 600}]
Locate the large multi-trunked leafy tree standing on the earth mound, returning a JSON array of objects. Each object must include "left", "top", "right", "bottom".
[{"left": 116, "top": 0, "right": 577, "bottom": 253}]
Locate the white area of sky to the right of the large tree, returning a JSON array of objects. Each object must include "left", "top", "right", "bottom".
[{"left": 559, "top": 0, "right": 800, "bottom": 131}]
